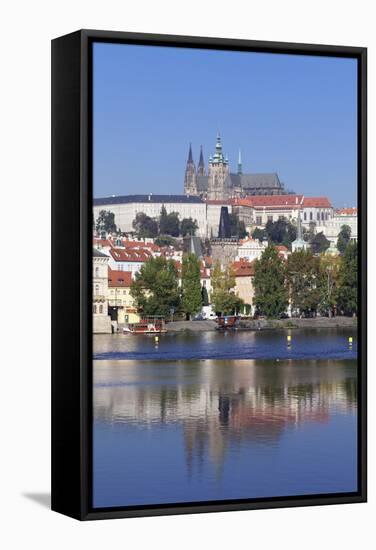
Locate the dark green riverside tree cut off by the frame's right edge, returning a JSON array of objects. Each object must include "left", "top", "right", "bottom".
[{"left": 337, "top": 242, "right": 358, "bottom": 315}]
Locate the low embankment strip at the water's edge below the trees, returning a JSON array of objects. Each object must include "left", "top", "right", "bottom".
[{"left": 166, "top": 317, "right": 358, "bottom": 332}]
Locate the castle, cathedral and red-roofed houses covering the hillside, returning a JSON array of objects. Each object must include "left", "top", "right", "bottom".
[{"left": 93, "top": 135, "right": 358, "bottom": 332}]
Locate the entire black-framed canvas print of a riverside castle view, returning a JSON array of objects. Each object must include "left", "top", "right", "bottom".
[{"left": 52, "top": 30, "right": 366, "bottom": 520}]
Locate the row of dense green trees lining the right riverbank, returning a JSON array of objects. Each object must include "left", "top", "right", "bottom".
[{"left": 253, "top": 242, "right": 358, "bottom": 318}]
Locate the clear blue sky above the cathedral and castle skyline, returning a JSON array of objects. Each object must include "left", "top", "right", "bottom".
[{"left": 93, "top": 43, "right": 357, "bottom": 207}]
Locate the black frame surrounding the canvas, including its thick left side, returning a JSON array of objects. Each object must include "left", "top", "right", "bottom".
[{"left": 52, "top": 30, "right": 367, "bottom": 520}]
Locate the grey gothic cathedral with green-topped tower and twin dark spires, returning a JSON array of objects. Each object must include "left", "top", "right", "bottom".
[{"left": 184, "top": 133, "right": 285, "bottom": 200}]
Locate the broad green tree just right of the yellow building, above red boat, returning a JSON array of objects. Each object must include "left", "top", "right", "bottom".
[{"left": 130, "top": 256, "right": 180, "bottom": 317}]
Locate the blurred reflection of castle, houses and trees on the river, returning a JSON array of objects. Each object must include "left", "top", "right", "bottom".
[{"left": 94, "top": 361, "right": 357, "bottom": 474}]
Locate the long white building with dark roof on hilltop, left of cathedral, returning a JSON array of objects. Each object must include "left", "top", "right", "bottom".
[{"left": 93, "top": 193, "right": 207, "bottom": 238}]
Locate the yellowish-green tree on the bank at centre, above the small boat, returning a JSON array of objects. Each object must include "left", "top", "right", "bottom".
[{"left": 211, "top": 261, "right": 243, "bottom": 315}]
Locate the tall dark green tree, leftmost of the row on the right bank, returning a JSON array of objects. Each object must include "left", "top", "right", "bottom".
[{"left": 253, "top": 245, "right": 288, "bottom": 317}]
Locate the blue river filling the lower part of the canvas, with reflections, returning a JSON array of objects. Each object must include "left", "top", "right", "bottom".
[{"left": 93, "top": 329, "right": 357, "bottom": 507}]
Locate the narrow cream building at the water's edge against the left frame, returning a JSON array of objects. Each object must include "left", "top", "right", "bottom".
[{"left": 93, "top": 248, "right": 112, "bottom": 334}]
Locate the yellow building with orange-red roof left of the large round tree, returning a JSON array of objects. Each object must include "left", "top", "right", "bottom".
[{"left": 107, "top": 269, "right": 140, "bottom": 325}]
